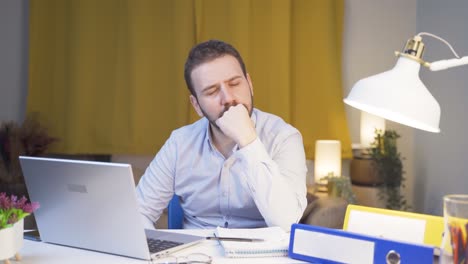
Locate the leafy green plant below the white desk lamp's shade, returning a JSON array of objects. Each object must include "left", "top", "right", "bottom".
[{"left": 368, "top": 130, "right": 410, "bottom": 210}]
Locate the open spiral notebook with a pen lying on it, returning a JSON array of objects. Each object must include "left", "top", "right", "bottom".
[{"left": 216, "top": 227, "right": 289, "bottom": 258}]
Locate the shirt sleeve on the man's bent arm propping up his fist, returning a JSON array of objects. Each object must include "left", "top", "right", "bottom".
[{"left": 237, "top": 130, "right": 307, "bottom": 231}]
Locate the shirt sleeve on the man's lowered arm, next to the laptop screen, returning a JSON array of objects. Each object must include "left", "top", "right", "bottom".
[{"left": 136, "top": 135, "right": 177, "bottom": 229}]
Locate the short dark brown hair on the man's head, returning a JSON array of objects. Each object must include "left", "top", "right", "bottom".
[{"left": 184, "top": 40, "right": 247, "bottom": 97}]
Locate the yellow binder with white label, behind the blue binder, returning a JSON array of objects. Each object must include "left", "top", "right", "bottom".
[{"left": 343, "top": 205, "right": 444, "bottom": 247}]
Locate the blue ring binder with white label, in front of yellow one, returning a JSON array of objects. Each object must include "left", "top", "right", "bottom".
[{"left": 288, "top": 224, "right": 434, "bottom": 264}]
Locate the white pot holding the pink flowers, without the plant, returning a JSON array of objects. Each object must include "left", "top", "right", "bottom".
[{"left": 0, "top": 219, "right": 24, "bottom": 263}]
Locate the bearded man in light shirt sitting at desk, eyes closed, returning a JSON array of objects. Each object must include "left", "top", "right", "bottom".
[{"left": 137, "top": 40, "right": 307, "bottom": 230}]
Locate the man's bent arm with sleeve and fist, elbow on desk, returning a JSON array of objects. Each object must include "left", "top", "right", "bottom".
[{"left": 216, "top": 105, "right": 307, "bottom": 230}]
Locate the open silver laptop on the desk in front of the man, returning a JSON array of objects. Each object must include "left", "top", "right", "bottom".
[{"left": 19, "top": 156, "right": 205, "bottom": 260}]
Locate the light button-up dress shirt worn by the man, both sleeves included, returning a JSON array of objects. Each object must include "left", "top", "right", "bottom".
[{"left": 137, "top": 109, "right": 307, "bottom": 230}]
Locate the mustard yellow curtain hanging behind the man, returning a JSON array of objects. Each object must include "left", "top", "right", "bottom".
[{"left": 28, "top": 0, "right": 351, "bottom": 158}]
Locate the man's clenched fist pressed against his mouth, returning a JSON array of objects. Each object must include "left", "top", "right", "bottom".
[{"left": 216, "top": 104, "right": 257, "bottom": 148}]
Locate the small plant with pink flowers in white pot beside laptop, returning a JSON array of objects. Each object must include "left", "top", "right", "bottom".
[{"left": 0, "top": 193, "right": 39, "bottom": 263}]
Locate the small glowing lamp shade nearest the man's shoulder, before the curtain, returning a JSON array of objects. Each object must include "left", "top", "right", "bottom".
[{"left": 314, "top": 140, "right": 341, "bottom": 183}]
